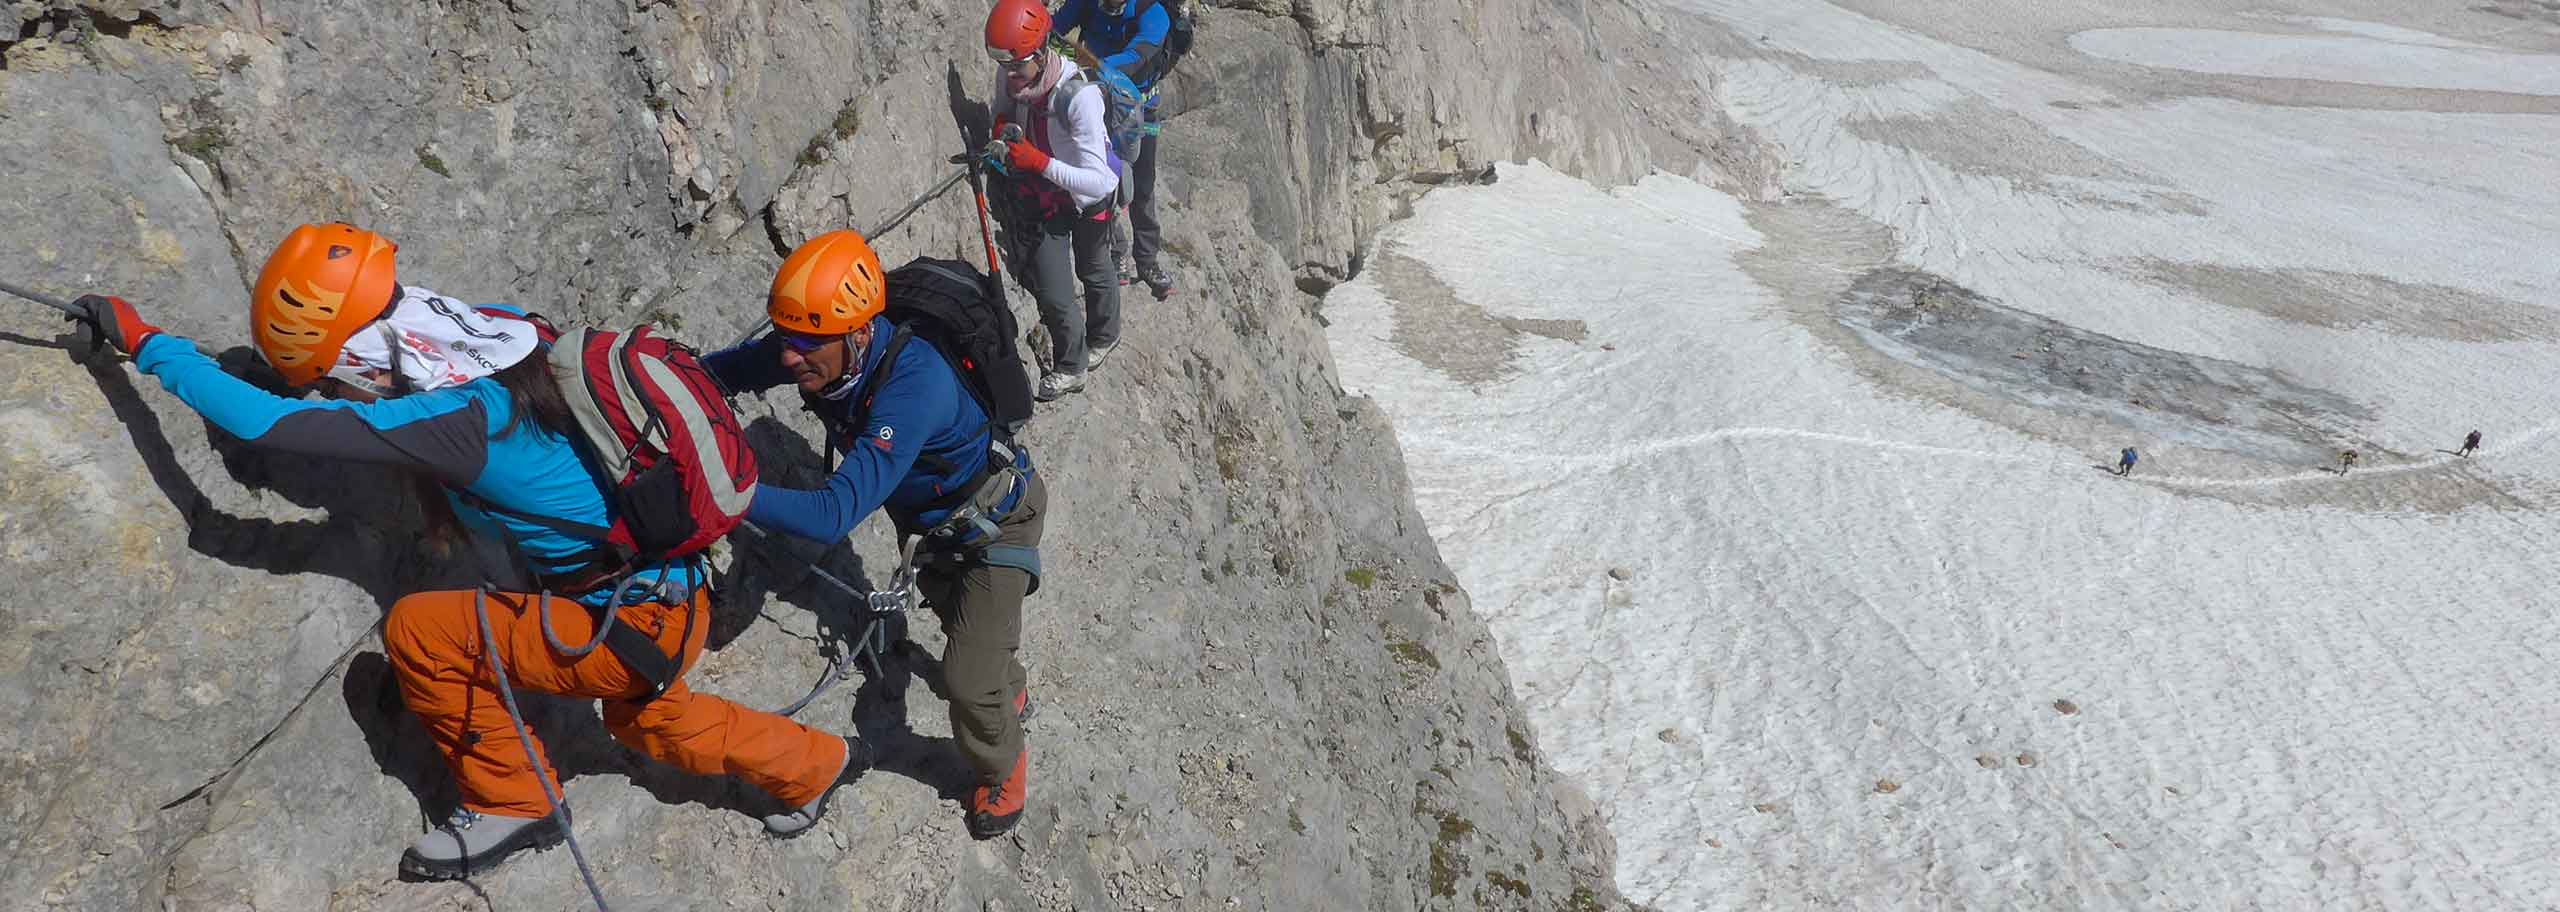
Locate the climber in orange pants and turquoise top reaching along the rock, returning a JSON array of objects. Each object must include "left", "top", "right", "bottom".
[{"left": 62, "top": 225, "right": 852, "bottom": 879}]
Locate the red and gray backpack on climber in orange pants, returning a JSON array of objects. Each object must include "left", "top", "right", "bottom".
[{"left": 483, "top": 315, "right": 755, "bottom": 566}]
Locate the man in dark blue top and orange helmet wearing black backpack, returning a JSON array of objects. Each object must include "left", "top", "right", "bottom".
[{"left": 701, "top": 231, "right": 1050, "bottom": 838}]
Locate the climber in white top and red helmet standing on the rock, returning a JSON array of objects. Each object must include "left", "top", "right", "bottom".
[{"left": 986, "top": 0, "right": 1119, "bottom": 402}]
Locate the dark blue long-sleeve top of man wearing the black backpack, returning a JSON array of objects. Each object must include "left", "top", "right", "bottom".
[{"left": 701, "top": 318, "right": 1029, "bottom": 543}]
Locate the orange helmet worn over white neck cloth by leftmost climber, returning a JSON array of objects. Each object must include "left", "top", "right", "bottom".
[{"left": 248, "top": 223, "right": 399, "bottom": 387}]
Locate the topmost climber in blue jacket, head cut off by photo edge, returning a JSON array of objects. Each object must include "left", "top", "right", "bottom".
[{"left": 1050, "top": 0, "right": 1172, "bottom": 300}]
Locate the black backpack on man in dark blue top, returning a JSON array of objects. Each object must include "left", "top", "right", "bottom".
[{"left": 855, "top": 256, "right": 1032, "bottom": 441}]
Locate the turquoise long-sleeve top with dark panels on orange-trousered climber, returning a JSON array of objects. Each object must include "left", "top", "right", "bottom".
[{"left": 133, "top": 325, "right": 701, "bottom": 605}]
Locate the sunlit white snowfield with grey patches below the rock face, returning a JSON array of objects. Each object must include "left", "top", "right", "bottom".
[{"left": 1324, "top": 0, "right": 2560, "bottom": 909}]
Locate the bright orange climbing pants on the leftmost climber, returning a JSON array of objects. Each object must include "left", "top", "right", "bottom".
[{"left": 381, "top": 589, "right": 845, "bottom": 817}]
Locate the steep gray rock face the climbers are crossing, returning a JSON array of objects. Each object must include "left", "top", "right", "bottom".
[{"left": 0, "top": 0, "right": 1720, "bottom": 909}]
